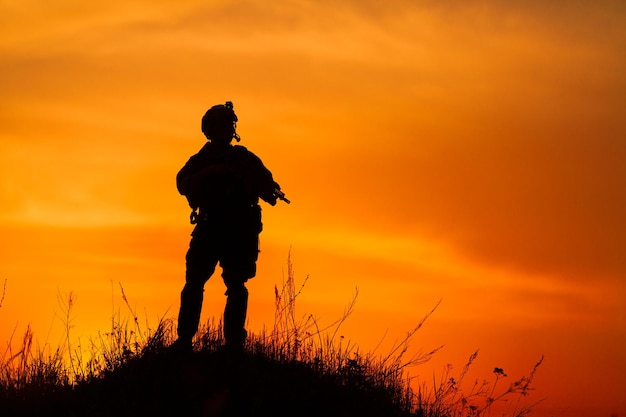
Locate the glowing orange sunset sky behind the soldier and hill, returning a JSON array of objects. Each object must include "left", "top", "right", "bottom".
[{"left": 0, "top": 0, "right": 626, "bottom": 417}]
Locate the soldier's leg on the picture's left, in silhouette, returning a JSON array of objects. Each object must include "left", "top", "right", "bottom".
[{"left": 178, "top": 231, "right": 217, "bottom": 345}]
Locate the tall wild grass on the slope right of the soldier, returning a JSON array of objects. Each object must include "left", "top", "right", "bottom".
[{"left": 244, "top": 257, "right": 543, "bottom": 417}]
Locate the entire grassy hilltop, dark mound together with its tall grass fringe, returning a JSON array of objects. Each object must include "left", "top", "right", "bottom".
[{"left": 0, "top": 266, "right": 541, "bottom": 417}]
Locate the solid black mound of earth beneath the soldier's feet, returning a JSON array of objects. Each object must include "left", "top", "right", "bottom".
[{"left": 0, "top": 342, "right": 411, "bottom": 417}]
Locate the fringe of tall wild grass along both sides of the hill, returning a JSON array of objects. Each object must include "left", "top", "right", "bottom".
[{"left": 0, "top": 257, "right": 543, "bottom": 417}]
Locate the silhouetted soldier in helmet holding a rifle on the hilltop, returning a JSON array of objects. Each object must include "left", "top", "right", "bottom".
[{"left": 176, "top": 102, "right": 288, "bottom": 349}]
